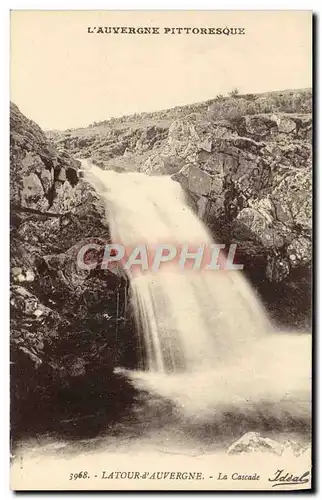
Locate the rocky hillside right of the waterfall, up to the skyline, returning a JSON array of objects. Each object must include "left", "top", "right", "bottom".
[{"left": 51, "top": 90, "right": 312, "bottom": 329}]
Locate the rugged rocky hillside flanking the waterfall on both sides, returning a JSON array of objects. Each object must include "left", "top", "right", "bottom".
[{"left": 10, "top": 91, "right": 312, "bottom": 440}]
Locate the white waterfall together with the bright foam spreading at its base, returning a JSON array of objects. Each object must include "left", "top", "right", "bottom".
[{"left": 83, "top": 162, "right": 311, "bottom": 422}]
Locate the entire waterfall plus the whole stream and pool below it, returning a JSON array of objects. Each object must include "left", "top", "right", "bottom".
[{"left": 10, "top": 160, "right": 312, "bottom": 470}]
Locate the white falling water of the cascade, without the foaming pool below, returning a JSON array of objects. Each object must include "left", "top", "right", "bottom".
[{"left": 82, "top": 160, "right": 270, "bottom": 373}]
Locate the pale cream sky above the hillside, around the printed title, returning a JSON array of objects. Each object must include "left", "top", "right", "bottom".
[{"left": 11, "top": 11, "right": 312, "bottom": 130}]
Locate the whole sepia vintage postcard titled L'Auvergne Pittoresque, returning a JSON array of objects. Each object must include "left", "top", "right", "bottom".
[{"left": 10, "top": 10, "right": 312, "bottom": 492}]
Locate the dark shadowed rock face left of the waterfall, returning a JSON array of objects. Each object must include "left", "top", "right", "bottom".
[{"left": 10, "top": 105, "right": 135, "bottom": 440}]
